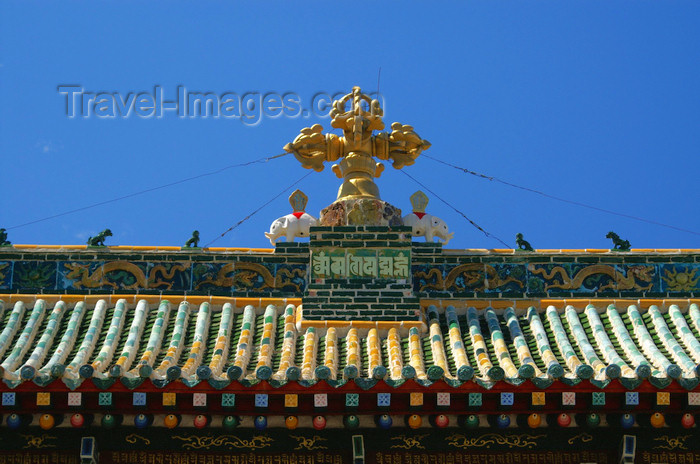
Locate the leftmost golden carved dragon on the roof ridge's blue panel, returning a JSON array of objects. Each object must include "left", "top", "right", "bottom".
[{"left": 65, "top": 261, "right": 189, "bottom": 290}]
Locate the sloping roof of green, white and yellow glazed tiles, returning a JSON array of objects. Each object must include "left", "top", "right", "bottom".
[{"left": 0, "top": 298, "right": 700, "bottom": 390}]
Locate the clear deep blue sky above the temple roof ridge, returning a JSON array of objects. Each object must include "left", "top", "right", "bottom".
[{"left": 0, "top": 1, "right": 700, "bottom": 248}]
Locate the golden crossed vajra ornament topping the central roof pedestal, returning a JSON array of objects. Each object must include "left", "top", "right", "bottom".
[{"left": 284, "top": 87, "right": 430, "bottom": 200}]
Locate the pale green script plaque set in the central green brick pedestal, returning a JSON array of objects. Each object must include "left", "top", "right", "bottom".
[{"left": 311, "top": 248, "right": 411, "bottom": 279}]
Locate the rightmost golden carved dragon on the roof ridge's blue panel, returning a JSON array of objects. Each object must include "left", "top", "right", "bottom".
[{"left": 528, "top": 264, "right": 654, "bottom": 291}]
